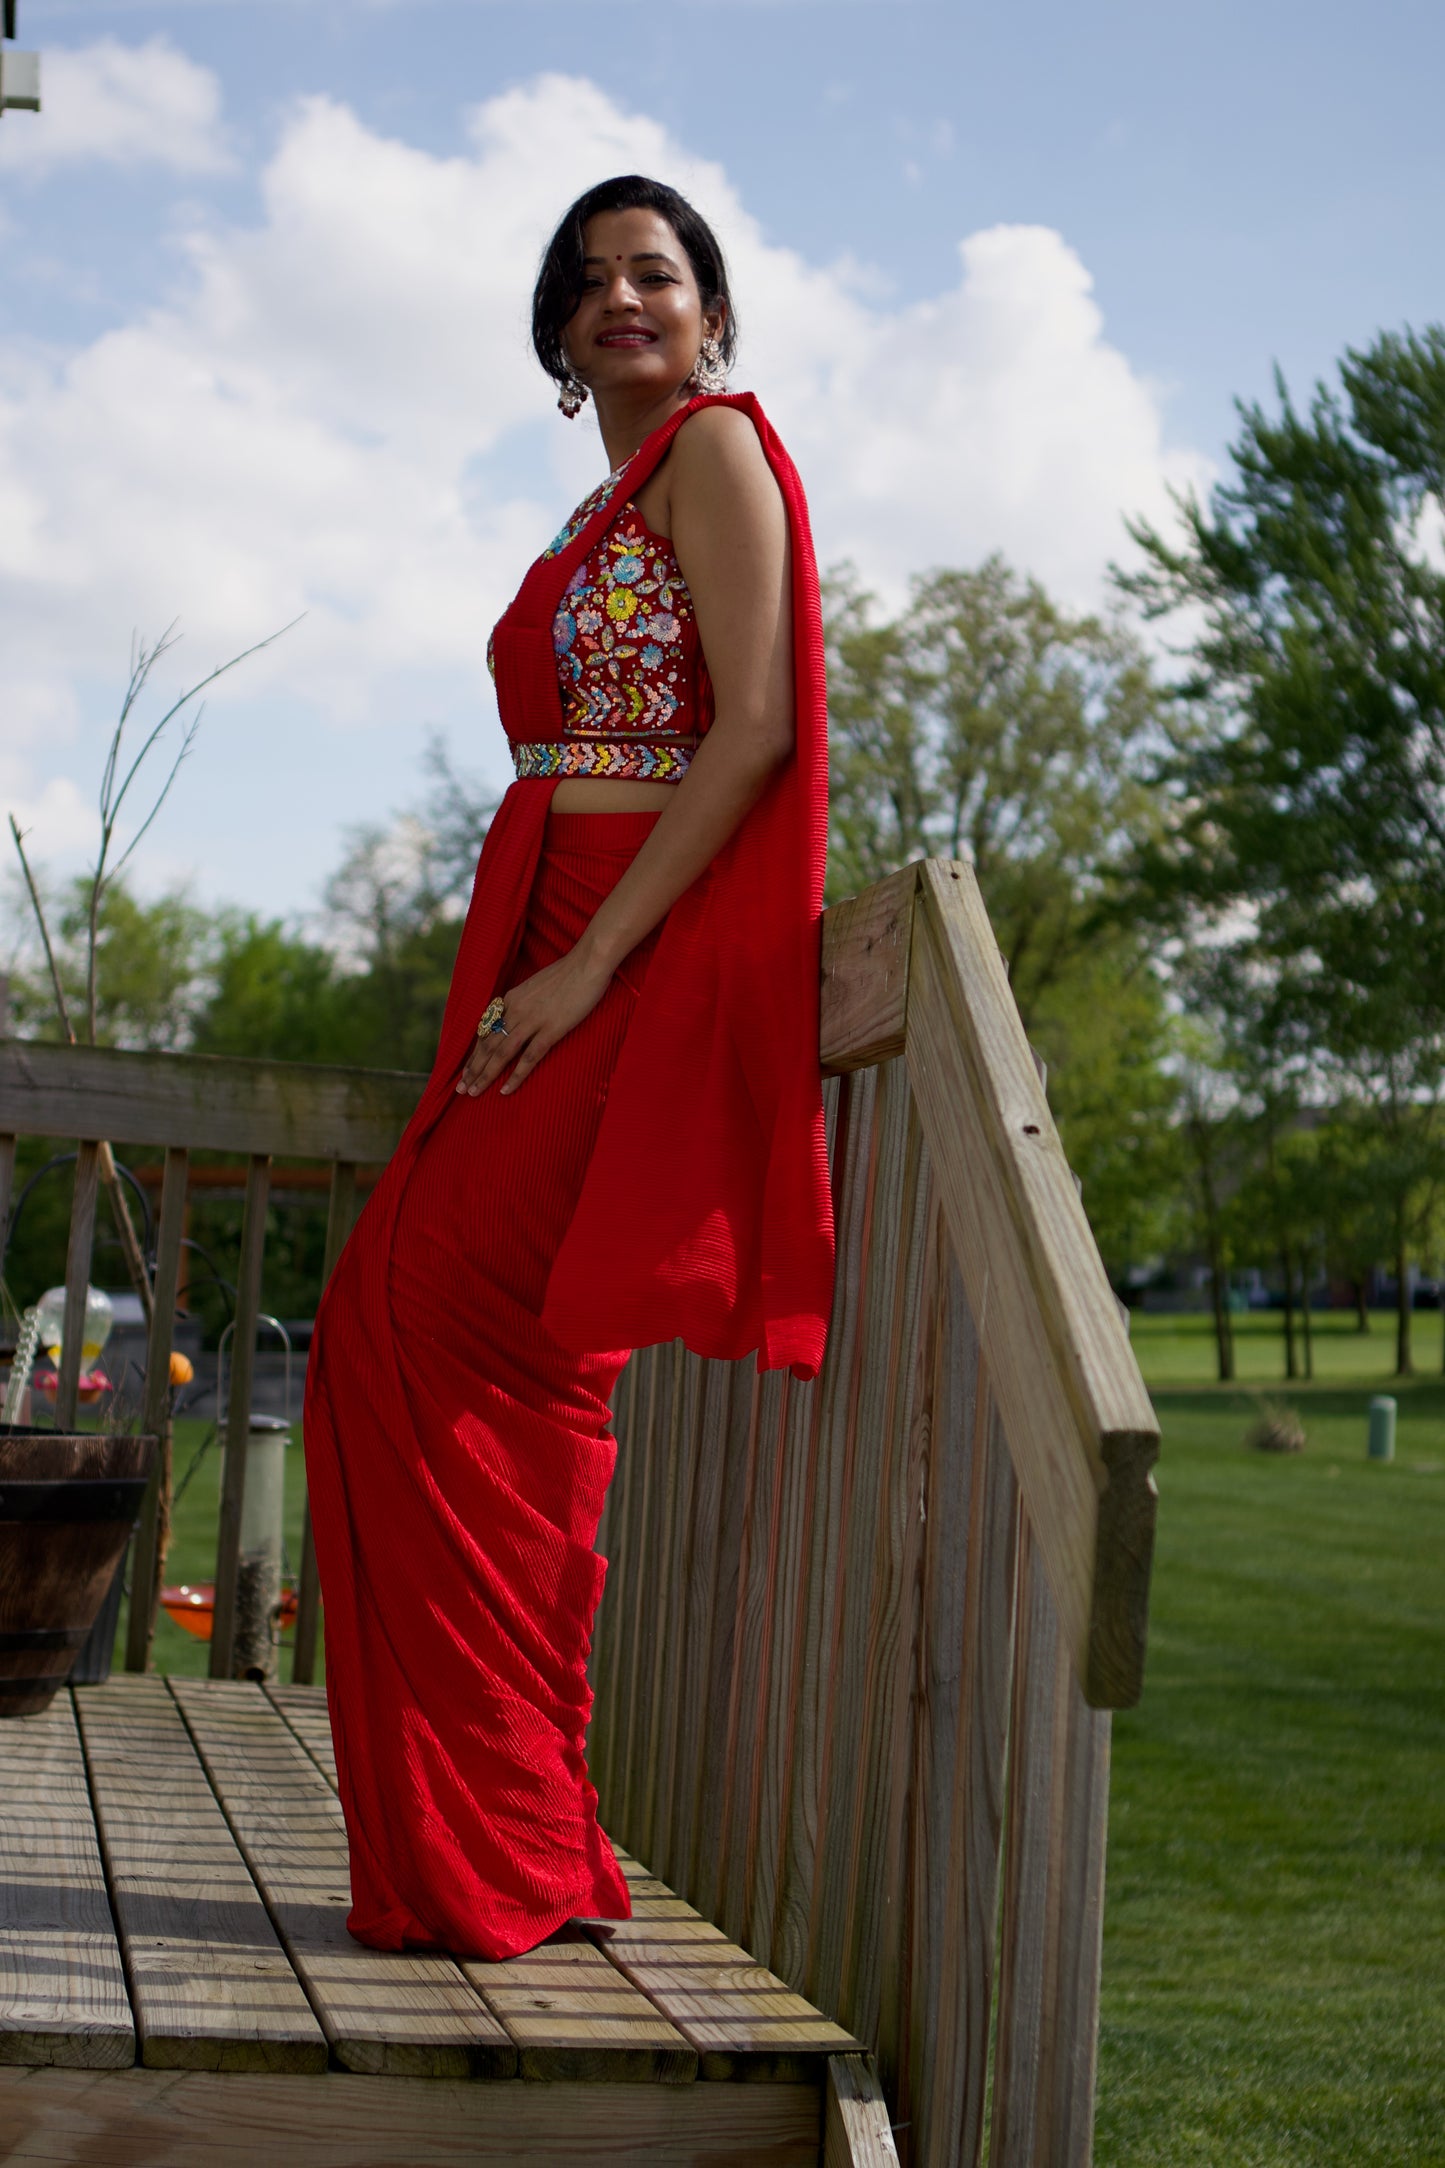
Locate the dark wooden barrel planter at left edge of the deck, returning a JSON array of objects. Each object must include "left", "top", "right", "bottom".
[{"left": 0, "top": 1424, "right": 156, "bottom": 1717}]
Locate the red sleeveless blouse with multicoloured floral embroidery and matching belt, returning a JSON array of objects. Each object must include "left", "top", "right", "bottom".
[{"left": 487, "top": 487, "right": 713, "bottom": 783}]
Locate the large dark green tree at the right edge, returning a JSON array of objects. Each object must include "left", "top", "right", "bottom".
[{"left": 1120, "top": 327, "right": 1445, "bottom": 1370}]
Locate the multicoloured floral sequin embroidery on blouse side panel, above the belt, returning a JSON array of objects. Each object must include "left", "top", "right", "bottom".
[{"left": 552, "top": 505, "right": 693, "bottom": 737}]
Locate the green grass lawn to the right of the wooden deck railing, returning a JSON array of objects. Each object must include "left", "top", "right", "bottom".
[{"left": 1094, "top": 1318, "right": 1445, "bottom": 2168}]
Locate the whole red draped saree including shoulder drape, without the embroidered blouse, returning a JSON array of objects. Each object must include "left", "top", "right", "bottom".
[{"left": 305, "top": 395, "right": 832, "bottom": 1958}]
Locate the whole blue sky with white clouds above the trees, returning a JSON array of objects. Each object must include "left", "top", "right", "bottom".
[{"left": 0, "top": 0, "right": 1445, "bottom": 913}]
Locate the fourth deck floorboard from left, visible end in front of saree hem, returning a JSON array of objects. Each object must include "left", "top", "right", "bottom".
[{"left": 461, "top": 1925, "right": 698, "bottom": 2086}]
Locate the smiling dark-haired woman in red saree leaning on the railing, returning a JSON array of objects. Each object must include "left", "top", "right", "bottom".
[{"left": 305, "top": 176, "right": 832, "bottom": 1958}]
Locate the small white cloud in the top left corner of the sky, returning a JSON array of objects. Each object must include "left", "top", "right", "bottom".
[{"left": 0, "top": 37, "right": 232, "bottom": 173}]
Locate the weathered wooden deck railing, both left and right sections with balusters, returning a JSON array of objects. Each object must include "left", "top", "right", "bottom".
[{"left": 0, "top": 861, "right": 1159, "bottom": 2168}]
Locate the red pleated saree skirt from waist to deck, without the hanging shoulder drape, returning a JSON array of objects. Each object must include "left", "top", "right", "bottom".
[{"left": 305, "top": 815, "right": 656, "bottom": 1958}]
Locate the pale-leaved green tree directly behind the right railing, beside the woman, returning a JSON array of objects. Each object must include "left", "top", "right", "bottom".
[{"left": 825, "top": 557, "right": 1174, "bottom": 1270}]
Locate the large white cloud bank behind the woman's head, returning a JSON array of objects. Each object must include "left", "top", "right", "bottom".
[{"left": 0, "top": 48, "right": 1202, "bottom": 906}]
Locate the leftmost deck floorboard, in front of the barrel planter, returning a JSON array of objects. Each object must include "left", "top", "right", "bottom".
[{"left": 0, "top": 1691, "right": 136, "bottom": 2070}]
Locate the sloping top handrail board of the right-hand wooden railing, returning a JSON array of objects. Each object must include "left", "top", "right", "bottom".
[{"left": 908, "top": 861, "right": 1159, "bottom": 1706}]
